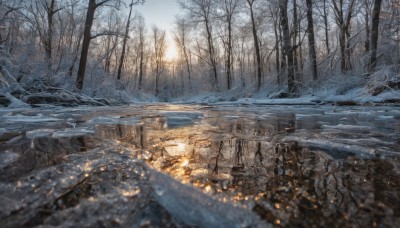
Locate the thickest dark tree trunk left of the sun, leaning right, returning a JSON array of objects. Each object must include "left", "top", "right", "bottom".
[{"left": 75, "top": 0, "right": 97, "bottom": 90}]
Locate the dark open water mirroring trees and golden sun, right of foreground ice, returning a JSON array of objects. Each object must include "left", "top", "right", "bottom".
[{"left": 109, "top": 106, "right": 400, "bottom": 226}]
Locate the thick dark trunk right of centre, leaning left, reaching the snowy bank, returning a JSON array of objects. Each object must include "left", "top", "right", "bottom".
[{"left": 279, "top": 0, "right": 298, "bottom": 96}]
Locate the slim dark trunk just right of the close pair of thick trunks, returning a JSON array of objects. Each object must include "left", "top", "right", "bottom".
[{"left": 306, "top": 0, "right": 318, "bottom": 81}]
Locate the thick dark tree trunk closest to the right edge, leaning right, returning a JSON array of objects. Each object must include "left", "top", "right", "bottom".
[{"left": 368, "top": 0, "right": 382, "bottom": 72}]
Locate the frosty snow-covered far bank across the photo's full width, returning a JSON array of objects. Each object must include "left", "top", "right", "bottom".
[{"left": 0, "top": 68, "right": 400, "bottom": 108}]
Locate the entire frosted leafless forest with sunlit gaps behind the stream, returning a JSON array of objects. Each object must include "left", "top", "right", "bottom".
[{"left": 0, "top": 0, "right": 400, "bottom": 106}]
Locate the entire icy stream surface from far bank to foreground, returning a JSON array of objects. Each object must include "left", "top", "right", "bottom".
[{"left": 0, "top": 104, "right": 400, "bottom": 227}]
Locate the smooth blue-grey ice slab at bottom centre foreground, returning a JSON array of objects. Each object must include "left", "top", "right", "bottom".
[{"left": 147, "top": 166, "right": 272, "bottom": 227}]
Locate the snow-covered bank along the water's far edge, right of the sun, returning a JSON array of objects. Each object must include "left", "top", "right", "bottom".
[{"left": 172, "top": 79, "right": 400, "bottom": 105}]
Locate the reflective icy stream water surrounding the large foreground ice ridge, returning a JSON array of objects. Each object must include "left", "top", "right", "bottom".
[{"left": 0, "top": 106, "right": 400, "bottom": 226}]
